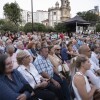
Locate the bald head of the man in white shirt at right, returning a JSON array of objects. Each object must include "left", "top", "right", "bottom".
[{"left": 79, "top": 44, "right": 91, "bottom": 58}]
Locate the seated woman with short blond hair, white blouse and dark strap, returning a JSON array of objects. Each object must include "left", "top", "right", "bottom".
[{"left": 17, "top": 51, "right": 60, "bottom": 100}]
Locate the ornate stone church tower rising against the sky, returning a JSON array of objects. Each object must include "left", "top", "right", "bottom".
[{"left": 61, "top": 0, "right": 71, "bottom": 21}]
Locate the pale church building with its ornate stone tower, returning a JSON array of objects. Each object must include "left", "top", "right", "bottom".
[{"left": 48, "top": 0, "right": 71, "bottom": 27}]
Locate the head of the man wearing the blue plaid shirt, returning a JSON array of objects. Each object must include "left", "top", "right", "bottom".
[{"left": 39, "top": 43, "right": 49, "bottom": 58}]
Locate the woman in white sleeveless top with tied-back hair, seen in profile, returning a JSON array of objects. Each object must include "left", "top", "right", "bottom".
[{"left": 72, "top": 55, "right": 96, "bottom": 100}]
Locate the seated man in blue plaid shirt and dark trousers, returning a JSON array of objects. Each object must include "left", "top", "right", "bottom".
[{"left": 34, "top": 45, "right": 70, "bottom": 100}]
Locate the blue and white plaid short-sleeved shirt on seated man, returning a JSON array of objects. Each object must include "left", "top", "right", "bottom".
[{"left": 34, "top": 55, "right": 54, "bottom": 77}]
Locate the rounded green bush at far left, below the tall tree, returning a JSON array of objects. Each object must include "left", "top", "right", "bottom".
[{"left": 1, "top": 21, "right": 17, "bottom": 32}]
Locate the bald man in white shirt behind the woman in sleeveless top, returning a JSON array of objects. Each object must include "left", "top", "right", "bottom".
[{"left": 79, "top": 44, "right": 100, "bottom": 89}]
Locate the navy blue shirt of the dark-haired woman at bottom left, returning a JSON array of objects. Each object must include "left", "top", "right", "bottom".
[{"left": 0, "top": 70, "right": 31, "bottom": 100}]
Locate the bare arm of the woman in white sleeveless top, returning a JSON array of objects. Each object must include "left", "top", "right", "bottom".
[{"left": 74, "top": 75, "right": 96, "bottom": 100}]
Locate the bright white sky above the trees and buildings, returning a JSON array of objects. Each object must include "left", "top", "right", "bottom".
[{"left": 0, "top": 0, "right": 100, "bottom": 18}]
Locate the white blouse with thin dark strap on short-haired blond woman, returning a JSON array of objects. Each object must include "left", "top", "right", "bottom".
[{"left": 17, "top": 63, "right": 42, "bottom": 88}]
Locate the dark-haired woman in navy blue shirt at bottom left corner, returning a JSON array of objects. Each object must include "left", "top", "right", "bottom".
[{"left": 0, "top": 54, "right": 32, "bottom": 100}]
